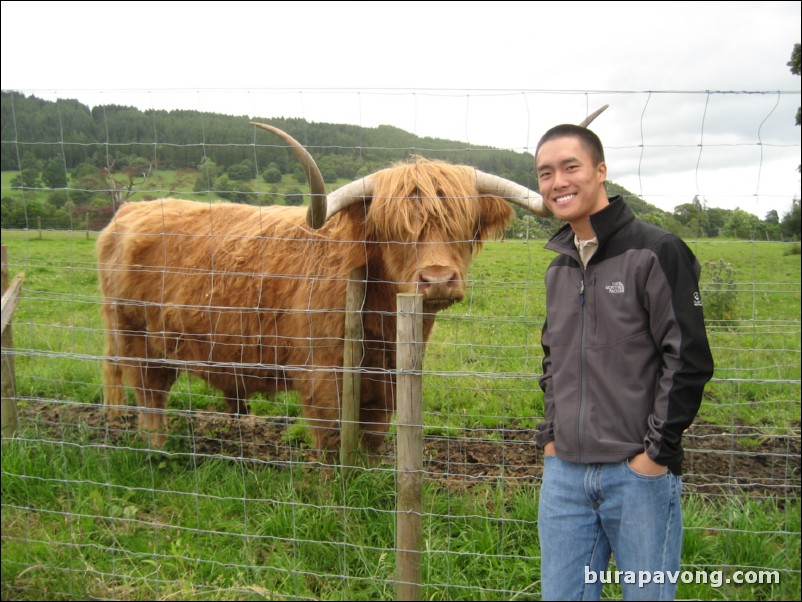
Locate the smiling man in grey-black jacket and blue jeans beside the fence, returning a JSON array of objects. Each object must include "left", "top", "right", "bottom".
[{"left": 535, "top": 125, "right": 713, "bottom": 600}]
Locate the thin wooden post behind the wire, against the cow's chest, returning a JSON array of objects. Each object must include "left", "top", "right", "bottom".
[{"left": 340, "top": 267, "right": 366, "bottom": 474}]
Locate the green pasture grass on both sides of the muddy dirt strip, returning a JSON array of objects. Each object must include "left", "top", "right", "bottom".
[{"left": 2, "top": 230, "right": 800, "bottom": 600}]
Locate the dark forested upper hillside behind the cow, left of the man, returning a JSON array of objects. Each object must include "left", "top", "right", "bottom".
[{"left": 0, "top": 91, "right": 535, "bottom": 187}]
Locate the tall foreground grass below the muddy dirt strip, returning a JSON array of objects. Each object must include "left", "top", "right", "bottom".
[{"left": 2, "top": 430, "right": 800, "bottom": 600}]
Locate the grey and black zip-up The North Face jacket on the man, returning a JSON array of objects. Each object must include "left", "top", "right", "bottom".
[{"left": 537, "top": 197, "right": 713, "bottom": 474}]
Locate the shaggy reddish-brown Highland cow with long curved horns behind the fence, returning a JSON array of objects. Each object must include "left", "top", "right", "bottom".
[{"left": 97, "top": 109, "right": 604, "bottom": 451}]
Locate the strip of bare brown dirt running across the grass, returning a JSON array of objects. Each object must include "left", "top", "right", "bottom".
[{"left": 14, "top": 401, "right": 802, "bottom": 499}]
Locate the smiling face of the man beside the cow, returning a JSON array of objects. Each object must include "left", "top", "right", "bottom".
[{"left": 535, "top": 137, "right": 607, "bottom": 230}]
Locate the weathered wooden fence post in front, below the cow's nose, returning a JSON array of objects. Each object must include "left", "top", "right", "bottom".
[{"left": 395, "top": 293, "right": 424, "bottom": 600}]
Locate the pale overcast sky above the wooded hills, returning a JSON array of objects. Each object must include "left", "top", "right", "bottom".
[{"left": 0, "top": 1, "right": 802, "bottom": 218}]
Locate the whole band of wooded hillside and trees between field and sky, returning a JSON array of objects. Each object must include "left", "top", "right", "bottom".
[{"left": 0, "top": 90, "right": 800, "bottom": 240}]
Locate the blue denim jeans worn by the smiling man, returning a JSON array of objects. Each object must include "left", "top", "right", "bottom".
[{"left": 538, "top": 456, "right": 682, "bottom": 600}]
